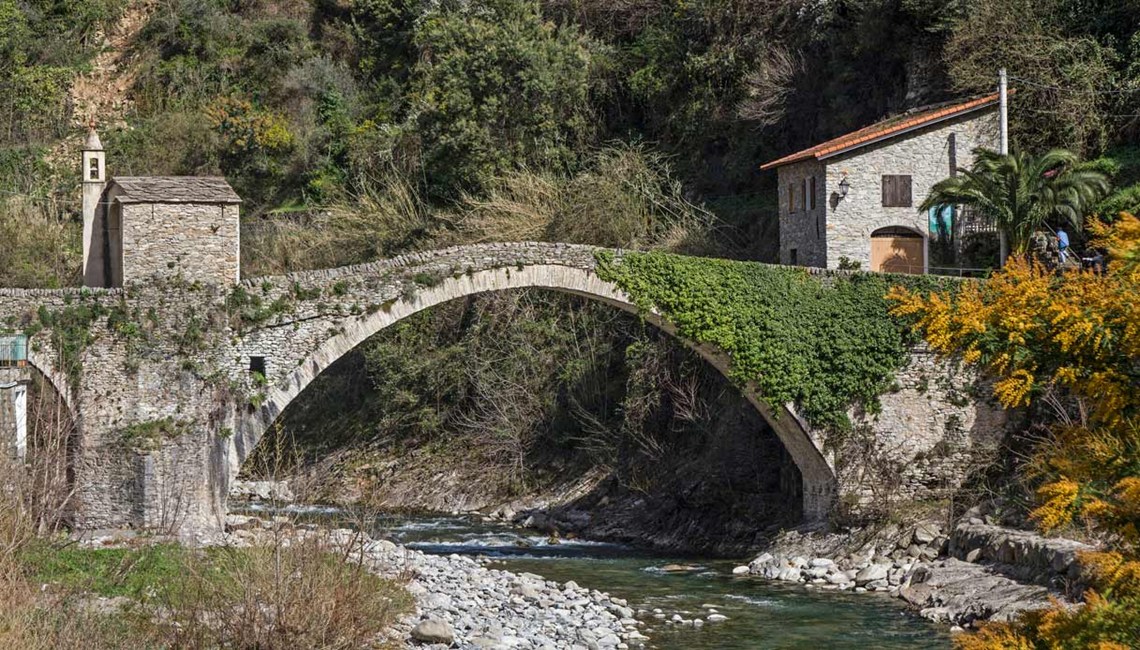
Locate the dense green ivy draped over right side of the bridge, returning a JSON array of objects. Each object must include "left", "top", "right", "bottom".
[{"left": 599, "top": 252, "right": 953, "bottom": 430}]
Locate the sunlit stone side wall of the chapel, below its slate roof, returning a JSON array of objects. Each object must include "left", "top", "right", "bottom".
[{"left": 122, "top": 203, "right": 241, "bottom": 286}]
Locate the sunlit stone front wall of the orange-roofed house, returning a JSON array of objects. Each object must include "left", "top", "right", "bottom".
[{"left": 820, "top": 108, "right": 999, "bottom": 269}]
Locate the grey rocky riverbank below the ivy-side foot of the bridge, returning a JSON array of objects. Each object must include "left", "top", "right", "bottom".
[{"left": 735, "top": 517, "right": 1089, "bottom": 628}]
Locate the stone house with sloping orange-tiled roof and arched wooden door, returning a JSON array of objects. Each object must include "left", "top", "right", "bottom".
[{"left": 760, "top": 94, "right": 999, "bottom": 274}]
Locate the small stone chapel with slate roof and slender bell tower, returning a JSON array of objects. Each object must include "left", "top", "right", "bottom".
[{"left": 83, "top": 129, "right": 242, "bottom": 287}]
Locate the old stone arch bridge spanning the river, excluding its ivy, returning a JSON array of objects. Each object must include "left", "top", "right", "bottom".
[{"left": 0, "top": 243, "right": 1003, "bottom": 533}]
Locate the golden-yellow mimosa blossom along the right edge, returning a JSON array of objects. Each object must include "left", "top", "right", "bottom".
[{"left": 888, "top": 214, "right": 1140, "bottom": 650}]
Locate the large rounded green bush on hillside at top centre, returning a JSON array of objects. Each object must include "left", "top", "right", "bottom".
[{"left": 409, "top": 0, "right": 593, "bottom": 196}]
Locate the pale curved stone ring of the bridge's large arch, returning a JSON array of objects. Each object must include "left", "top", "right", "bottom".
[{"left": 229, "top": 263, "right": 837, "bottom": 521}]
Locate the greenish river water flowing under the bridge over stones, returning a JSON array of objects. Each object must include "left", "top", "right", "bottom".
[{"left": 245, "top": 506, "right": 951, "bottom": 650}]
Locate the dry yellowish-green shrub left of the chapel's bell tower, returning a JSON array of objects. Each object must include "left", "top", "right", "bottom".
[{"left": 0, "top": 194, "right": 83, "bottom": 289}]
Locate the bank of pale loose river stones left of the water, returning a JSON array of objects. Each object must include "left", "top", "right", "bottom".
[{"left": 223, "top": 515, "right": 645, "bottom": 650}]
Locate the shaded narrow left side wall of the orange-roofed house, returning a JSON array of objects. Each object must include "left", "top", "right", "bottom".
[{"left": 779, "top": 160, "right": 828, "bottom": 267}]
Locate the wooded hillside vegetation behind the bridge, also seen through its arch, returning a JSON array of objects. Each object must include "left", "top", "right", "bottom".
[{"left": 0, "top": 0, "right": 1140, "bottom": 517}]
